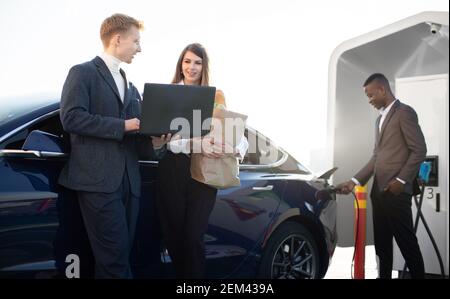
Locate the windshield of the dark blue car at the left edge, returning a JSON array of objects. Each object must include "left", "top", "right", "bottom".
[{"left": 0, "top": 96, "right": 55, "bottom": 125}]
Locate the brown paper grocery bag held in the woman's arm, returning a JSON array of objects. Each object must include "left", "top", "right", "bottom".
[{"left": 191, "top": 109, "right": 247, "bottom": 189}]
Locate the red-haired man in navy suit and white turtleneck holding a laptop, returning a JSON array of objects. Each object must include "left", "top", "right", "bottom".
[{"left": 59, "top": 14, "right": 170, "bottom": 278}]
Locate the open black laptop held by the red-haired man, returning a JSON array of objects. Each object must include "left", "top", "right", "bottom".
[{"left": 139, "top": 83, "right": 216, "bottom": 138}]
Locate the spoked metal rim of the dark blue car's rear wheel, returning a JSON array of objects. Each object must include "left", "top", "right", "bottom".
[{"left": 271, "top": 235, "right": 317, "bottom": 279}]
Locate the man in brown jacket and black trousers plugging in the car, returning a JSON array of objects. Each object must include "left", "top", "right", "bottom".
[{"left": 337, "top": 73, "right": 427, "bottom": 278}]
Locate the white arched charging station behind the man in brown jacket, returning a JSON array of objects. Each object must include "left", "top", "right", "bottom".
[{"left": 327, "top": 12, "right": 449, "bottom": 275}]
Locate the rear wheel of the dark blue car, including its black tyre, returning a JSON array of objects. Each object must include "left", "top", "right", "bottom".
[{"left": 259, "top": 221, "right": 319, "bottom": 279}]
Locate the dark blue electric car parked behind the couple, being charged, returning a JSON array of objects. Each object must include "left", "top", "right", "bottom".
[{"left": 0, "top": 98, "right": 336, "bottom": 279}]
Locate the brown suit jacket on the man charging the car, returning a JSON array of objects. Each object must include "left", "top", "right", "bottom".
[{"left": 354, "top": 101, "right": 427, "bottom": 194}]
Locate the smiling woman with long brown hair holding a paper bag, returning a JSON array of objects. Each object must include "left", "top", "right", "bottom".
[{"left": 157, "top": 44, "right": 248, "bottom": 278}]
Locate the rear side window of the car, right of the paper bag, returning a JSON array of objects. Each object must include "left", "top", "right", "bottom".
[{"left": 241, "top": 129, "right": 283, "bottom": 165}]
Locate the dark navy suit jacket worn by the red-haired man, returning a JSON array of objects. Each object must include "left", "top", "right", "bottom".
[{"left": 59, "top": 57, "right": 163, "bottom": 196}]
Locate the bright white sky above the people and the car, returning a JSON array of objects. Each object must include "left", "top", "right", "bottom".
[{"left": 0, "top": 0, "right": 449, "bottom": 171}]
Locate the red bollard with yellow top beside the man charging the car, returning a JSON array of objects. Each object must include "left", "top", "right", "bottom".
[{"left": 353, "top": 186, "right": 367, "bottom": 279}]
